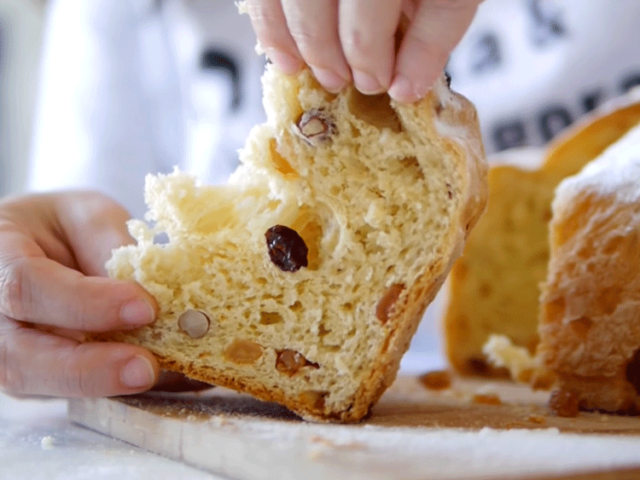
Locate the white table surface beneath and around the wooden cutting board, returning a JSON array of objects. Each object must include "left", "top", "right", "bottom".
[{"left": 0, "top": 355, "right": 442, "bottom": 480}]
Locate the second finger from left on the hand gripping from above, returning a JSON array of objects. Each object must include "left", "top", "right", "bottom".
[{"left": 282, "top": 0, "right": 351, "bottom": 92}]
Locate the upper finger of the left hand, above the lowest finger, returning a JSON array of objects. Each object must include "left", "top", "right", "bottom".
[{"left": 0, "top": 255, "right": 157, "bottom": 332}]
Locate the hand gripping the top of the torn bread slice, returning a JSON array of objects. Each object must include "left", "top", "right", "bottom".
[{"left": 247, "top": 0, "right": 482, "bottom": 103}]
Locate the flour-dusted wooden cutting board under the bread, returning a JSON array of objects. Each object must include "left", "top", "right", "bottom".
[{"left": 69, "top": 378, "right": 640, "bottom": 480}]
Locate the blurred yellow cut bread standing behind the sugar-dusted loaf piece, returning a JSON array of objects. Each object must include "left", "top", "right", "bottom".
[{"left": 443, "top": 95, "right": 640, "bottom": 377}]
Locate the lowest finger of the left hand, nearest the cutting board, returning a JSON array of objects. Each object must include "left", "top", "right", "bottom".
[{"left": 0, "top": 320, "right": 159, "bottom": 397}]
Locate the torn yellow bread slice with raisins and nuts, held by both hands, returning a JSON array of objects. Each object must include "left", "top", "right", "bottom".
[{"left": 95, "top": 67, "right": 487, "bottom": 422}]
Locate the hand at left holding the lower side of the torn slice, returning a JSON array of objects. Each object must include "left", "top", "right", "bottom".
[{"left": 0, "top": 193, "right": 159, "bottom": 397}]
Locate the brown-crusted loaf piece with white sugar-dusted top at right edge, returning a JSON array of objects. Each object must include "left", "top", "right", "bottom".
[{"left": 538, "top": 123, "right": 640, "bottom": 413}]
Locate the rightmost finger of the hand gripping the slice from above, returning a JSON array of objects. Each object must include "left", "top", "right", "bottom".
[{"left": 389, "top": 0, "right": 481, "bottom": 103}]
